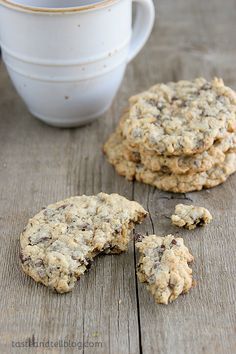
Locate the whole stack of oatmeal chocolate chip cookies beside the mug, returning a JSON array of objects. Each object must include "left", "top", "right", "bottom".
[{"left": 104, "top": 78, "right": 236, "bottom": 193}]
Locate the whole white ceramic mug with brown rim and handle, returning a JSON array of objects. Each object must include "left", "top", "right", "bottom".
[{"left": 0, "top": 0, "right": 155, "bottom": 127}]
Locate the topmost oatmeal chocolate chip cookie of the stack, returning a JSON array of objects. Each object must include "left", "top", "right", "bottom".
[{"left": 121, "top": 78, "right": 236, "bottom": 156}]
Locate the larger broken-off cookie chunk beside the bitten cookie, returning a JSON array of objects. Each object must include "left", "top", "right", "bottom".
[{"left": 136, "top": 235, "right": 193, "bottom": 305}]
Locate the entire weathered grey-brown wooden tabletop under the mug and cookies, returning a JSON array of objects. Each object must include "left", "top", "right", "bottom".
[{"left": 0, "top": 0, "right": 236, "bottom": 354}]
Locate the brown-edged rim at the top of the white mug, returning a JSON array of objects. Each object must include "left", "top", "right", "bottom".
[{"left": 0, "top": 0, "right": 120, "bottom": 15}]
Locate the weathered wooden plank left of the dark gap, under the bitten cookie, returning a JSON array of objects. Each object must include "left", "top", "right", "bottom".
[{"left": 0, "top": 67, "right": 139, "bottom": 354}]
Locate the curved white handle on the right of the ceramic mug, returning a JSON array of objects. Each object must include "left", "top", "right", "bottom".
[{"left": 128, "top": 0, "right": 155, "bottom": 62}]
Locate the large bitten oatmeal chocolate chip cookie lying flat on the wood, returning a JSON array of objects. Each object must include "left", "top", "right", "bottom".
[{"left": 20, "top": 193, "right": 147, "bottom": 293}]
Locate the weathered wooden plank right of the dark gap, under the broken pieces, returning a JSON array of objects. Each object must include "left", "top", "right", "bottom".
[{"left": 134, "top": 0, "right": 236, "bottom": 354}]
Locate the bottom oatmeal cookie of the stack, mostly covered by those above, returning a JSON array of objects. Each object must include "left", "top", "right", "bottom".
[{"left": 104, "top": 132, "right": 236, "bottom": 193}]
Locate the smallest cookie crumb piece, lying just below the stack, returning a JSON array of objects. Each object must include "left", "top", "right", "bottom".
[{"left": 171, "top": 204, "right": 212, "bottom": 230}]
